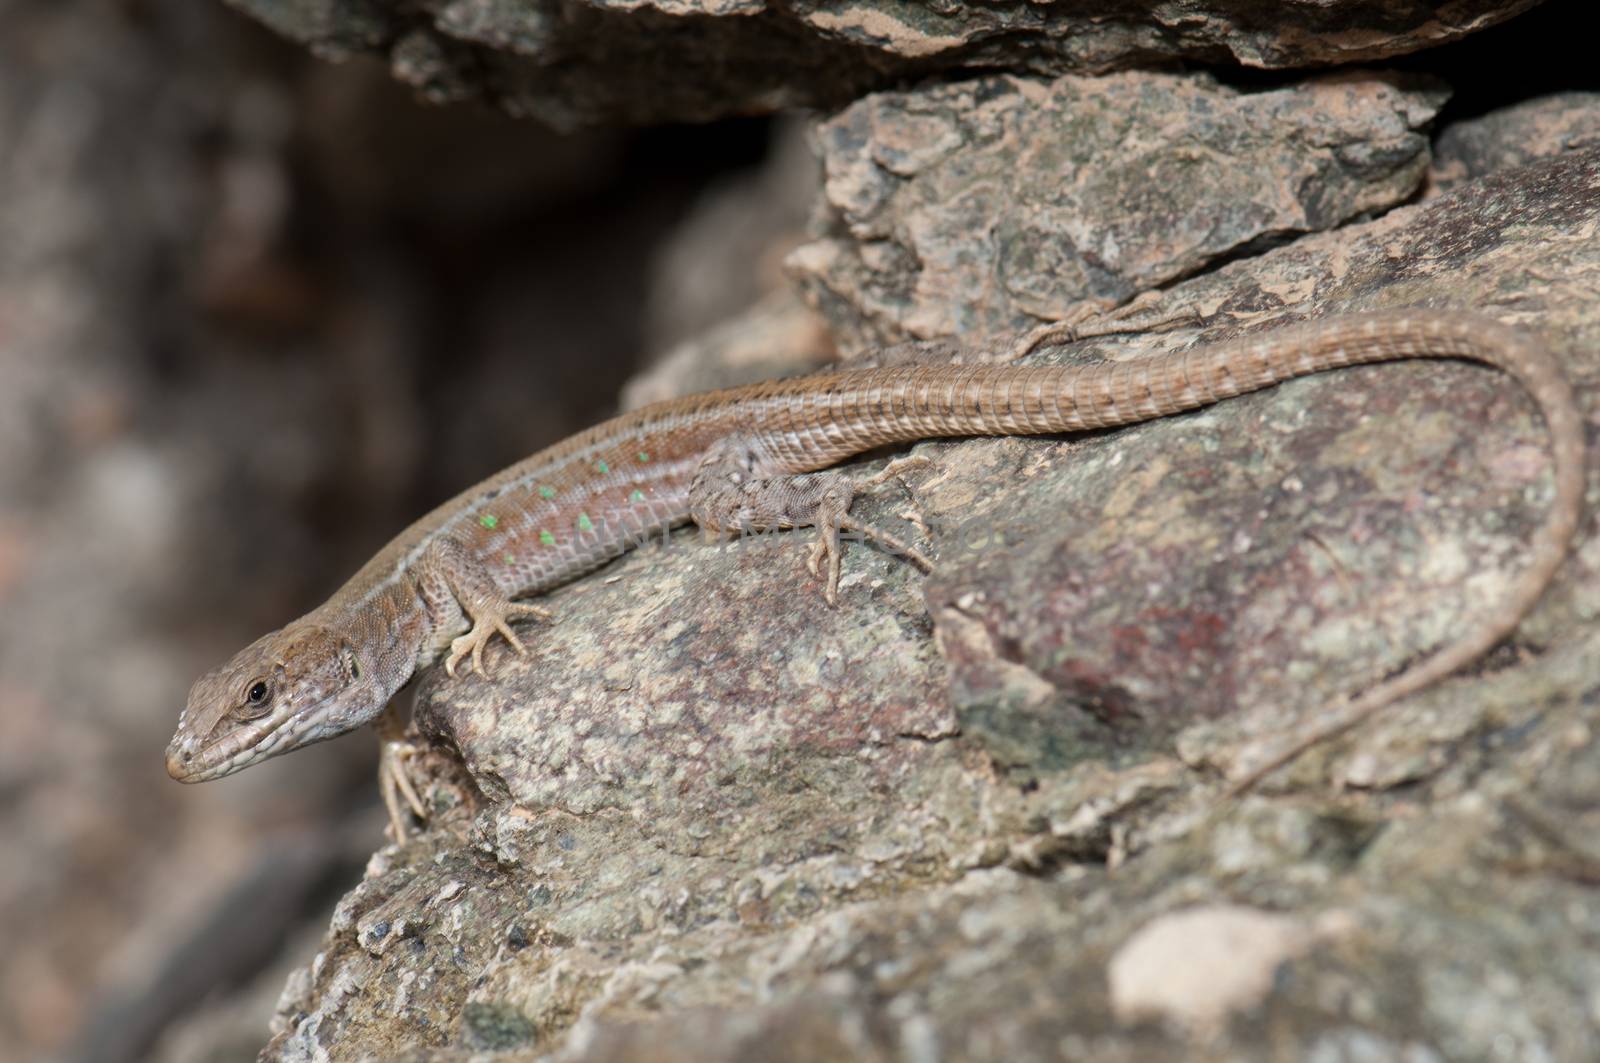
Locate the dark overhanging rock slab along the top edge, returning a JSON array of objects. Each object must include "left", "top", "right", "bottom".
[{"left": 219, "top": 0, "right": 1538, "bottom": 128}]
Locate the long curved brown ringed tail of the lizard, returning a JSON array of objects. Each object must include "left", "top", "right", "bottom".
[{"left": 834, "top": 311, "right": 1584, "bottom": 794}]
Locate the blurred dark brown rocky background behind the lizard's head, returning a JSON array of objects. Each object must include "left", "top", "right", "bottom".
[{"left": 0, "top": 0, "right": 819, "bottom": 1060}]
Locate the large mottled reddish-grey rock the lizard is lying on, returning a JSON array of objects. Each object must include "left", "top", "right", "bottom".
[{"left": 264, "top": 126, "right": 1600, "bottom": 1060}]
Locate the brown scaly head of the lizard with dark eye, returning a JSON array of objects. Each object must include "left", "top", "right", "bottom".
[{"left": 166, "top": 618, "right": 400, "bottom": 783}]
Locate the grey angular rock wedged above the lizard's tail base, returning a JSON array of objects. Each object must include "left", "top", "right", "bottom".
[{"left": 789, "top": 72, "right": 1446, "bottom": 351}]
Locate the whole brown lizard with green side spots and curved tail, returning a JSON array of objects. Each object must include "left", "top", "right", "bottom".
[{"left": 166, "top": 309, "right": 1584, "bottom": 840}]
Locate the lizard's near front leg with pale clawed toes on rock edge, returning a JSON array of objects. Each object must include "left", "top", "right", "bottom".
[{"left": 416, "top": 536, "right": 550, "bottom": 676}]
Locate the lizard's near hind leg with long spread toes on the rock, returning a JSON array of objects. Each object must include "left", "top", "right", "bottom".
[{"left": 690, "top": 437, "right": 933, "bottom": 605}]
